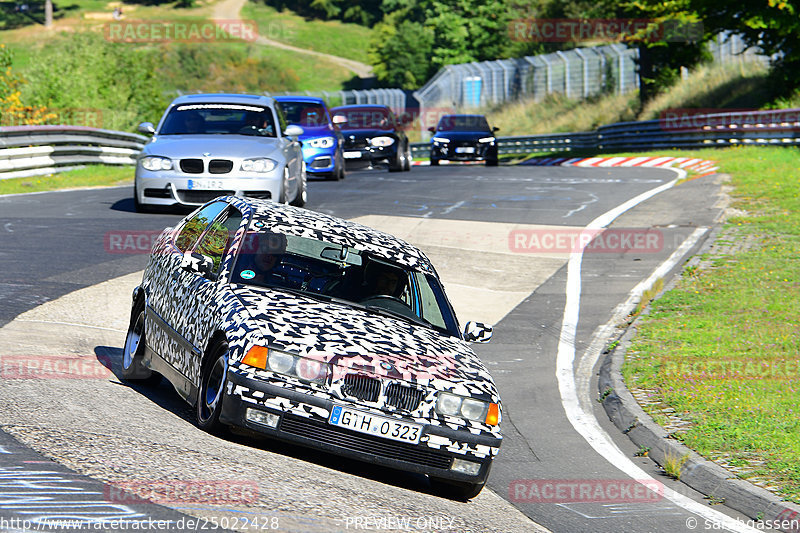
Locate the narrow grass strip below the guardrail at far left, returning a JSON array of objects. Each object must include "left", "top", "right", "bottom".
[{"left": 0, "top": 165, "right": 133, "bottom": 194}]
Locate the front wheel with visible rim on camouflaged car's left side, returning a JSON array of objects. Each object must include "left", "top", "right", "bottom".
[{"left": 195, "top": 341, "right": 228, "bottom": 434}]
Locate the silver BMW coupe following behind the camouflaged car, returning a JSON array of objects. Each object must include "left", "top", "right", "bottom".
[{"left": 134, "top": 94, "right": 307, "bottom": 211}]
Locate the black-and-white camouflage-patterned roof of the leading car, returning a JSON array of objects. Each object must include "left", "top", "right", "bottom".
[{"left": 224, "top": 196, "right": 436, "bottom": 275}]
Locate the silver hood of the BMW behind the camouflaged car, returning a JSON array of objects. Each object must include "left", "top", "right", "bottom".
[{"left": 142, "top": 135, "right": 280, "bottom": 159}]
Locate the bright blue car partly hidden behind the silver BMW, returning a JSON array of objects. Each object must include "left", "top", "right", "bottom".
[{"left": 275, "top": 96, "right": 345, "bottom": 181}]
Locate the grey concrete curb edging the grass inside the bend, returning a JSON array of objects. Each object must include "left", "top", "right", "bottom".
[{"left": 598, "top": 224, "right": 800, "bottom": 533}]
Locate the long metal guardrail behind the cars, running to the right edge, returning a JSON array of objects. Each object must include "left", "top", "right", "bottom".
[{"left": 411, "top": 109, "right": 800, "bottom": 158}]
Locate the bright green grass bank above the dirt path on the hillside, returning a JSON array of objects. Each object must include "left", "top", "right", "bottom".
[{"left": 241, "top": 2, "right": 372, "bottom": 63}]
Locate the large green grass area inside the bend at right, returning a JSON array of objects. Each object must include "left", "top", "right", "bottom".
[{"left": 623, "top": 147, "right": 800, "bottom": 502}]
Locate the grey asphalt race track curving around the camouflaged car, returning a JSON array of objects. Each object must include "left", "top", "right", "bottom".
[{"left": 0, "top": 165, "right": 760, "bottom": 532}]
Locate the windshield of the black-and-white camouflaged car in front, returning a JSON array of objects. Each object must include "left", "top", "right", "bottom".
[{"left": 231, "top": 232, "right": 459, "bottom": 337}]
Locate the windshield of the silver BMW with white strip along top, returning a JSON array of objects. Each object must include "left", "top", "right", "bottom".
[{"left": 159, "top": 104, "right": 275, "bottom": 137}]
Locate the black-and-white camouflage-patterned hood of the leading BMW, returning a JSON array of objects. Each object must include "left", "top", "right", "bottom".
[{"left": 231, "top": 285, "right": 496, "bottom": 395}]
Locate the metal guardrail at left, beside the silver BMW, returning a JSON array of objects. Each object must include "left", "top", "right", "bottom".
[{"left": 0, "top": 126, "right": 149, "bottom": 179}]
